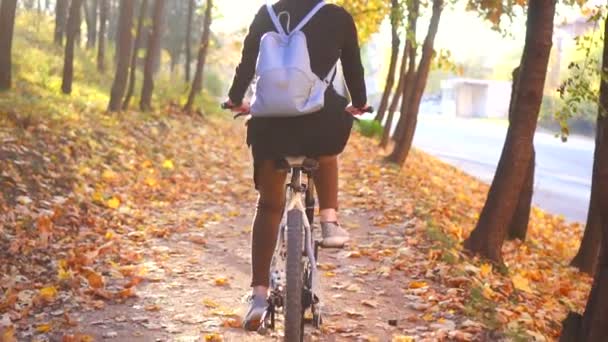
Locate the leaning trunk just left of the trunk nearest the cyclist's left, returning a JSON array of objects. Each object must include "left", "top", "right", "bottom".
[{"left": 139, "top": 0, "right": 165, "bottom": 110}]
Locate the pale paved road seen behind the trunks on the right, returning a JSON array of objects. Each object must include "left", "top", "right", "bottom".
[{"left": 414, "top": 115, "right": 594, "bottom": 222}]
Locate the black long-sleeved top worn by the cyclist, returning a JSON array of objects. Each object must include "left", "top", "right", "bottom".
[{"left": 229, "top": 0, "right": 367, "bottom": 108}]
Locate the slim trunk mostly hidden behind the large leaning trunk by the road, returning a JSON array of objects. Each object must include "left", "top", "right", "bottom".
[{"left": 507, "top": 67, "right": 536, "bottom": 241}]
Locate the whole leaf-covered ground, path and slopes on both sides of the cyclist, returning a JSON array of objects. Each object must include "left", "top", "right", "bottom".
[{"left": 0, "top": 11, "right": 590, "bottom": 341}]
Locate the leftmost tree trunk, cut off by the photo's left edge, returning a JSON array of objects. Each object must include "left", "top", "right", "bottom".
[{"left": 0, "top": 0, "right": 17, "bottom": 90}]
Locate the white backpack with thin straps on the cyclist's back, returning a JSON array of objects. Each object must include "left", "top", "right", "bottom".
[{"left": 251, "top": 1, "right": 336, "bottom": 117}]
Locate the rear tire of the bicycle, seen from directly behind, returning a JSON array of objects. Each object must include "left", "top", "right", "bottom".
[{"left": 285, "top": 209, "right": 304, "bottom": 342}]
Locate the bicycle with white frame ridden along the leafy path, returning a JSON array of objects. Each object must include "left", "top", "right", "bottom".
[{"left": 222, "top": 103, "right": 373, "bottom": 342}]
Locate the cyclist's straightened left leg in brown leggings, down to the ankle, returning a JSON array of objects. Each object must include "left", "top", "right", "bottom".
[{"left": 251, "top": 160, "right": 287, "bottom": 295}]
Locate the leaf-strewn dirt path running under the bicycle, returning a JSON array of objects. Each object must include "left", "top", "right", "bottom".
[{"left": 0, "top": 121, "right": 486, "bottom": 341}]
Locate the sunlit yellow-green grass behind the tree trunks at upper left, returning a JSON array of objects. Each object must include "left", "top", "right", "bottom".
[{"left": 0, "top": 11, "right": 217, "bottom": 120}]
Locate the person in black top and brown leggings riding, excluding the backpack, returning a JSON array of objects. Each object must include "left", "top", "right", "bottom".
[{"left": 226, "top": 0, "right": 368, "bottom": 329}]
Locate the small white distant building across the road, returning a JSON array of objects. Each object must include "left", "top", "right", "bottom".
[{"left": 441, "top": 78, "right": 511, "bottom": 118}]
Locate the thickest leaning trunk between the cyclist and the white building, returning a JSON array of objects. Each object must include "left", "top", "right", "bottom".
[{"left": 388, "top": 0, "right": 443, "bottom": 165}]
